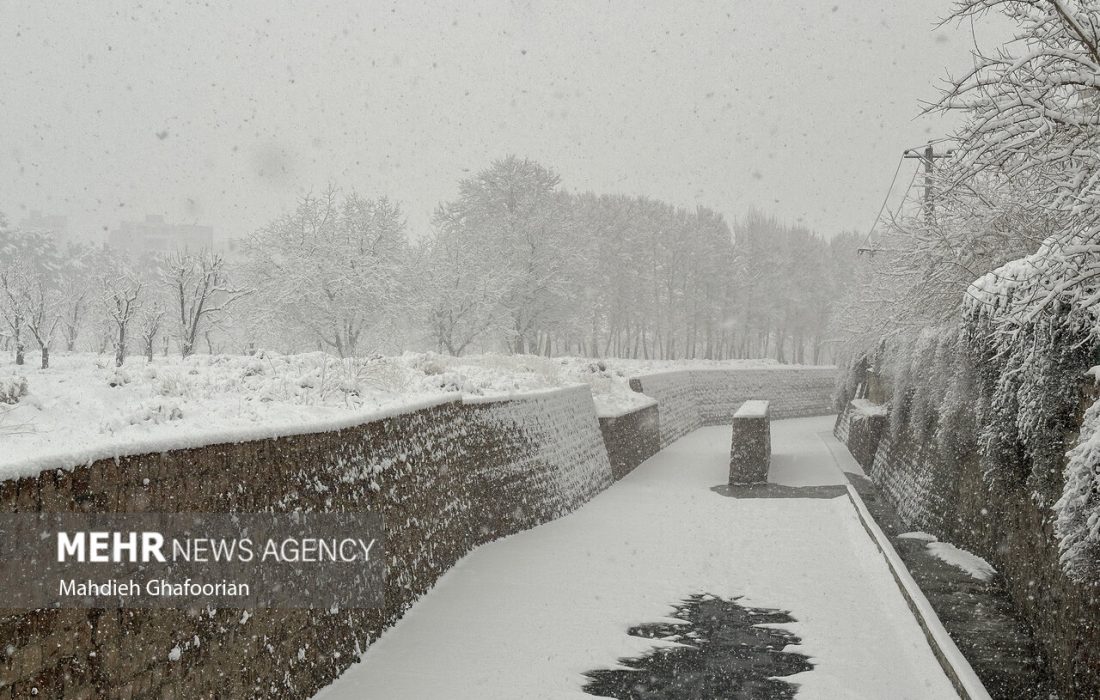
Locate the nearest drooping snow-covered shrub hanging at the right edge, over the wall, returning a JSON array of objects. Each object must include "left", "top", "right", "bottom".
[{"left": 967, "top": 257, "right": 1100, "bottom": 581}]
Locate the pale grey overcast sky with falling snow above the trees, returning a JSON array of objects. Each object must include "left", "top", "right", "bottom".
[{"left": 0, "top": 0, "right": 1012, "bottom": 237}]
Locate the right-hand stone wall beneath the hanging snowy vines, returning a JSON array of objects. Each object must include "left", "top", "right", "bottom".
[{"left": 834, "top": 360, "right": 1100, "bottom": 700}]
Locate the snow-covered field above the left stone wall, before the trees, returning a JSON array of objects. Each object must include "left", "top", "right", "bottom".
[{"left": 0, "top": 352, "right": 780, "bottom": 478}]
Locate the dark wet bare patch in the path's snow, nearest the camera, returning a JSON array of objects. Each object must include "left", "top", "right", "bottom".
[{"left": 584, "top": 595, "right": 813, "bottom": 700}]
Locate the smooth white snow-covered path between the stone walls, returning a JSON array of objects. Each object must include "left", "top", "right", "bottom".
[{"left": 318, "top": 417, "right": 957, "bottom": 700}]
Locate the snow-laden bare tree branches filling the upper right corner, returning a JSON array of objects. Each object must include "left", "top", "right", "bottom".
[{"left": 936, "top": 0, "right": 1100, "bottom": 325}]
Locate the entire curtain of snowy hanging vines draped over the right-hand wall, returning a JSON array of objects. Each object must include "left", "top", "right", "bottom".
[{"left": 846, "top": 259, "right": 1100, "bottom": 580}]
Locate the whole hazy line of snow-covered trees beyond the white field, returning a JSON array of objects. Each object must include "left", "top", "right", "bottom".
[{"left": 0, "top": 156, "right": 858, "bottom": 364}]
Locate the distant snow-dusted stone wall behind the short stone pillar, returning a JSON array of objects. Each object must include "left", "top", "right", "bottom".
[{"left": 630, "top": 367, "right": 836, "bottom": 447}]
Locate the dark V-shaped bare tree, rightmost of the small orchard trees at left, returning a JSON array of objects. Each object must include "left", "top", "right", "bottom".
[{"left": 160, "top": 251, "right": 252, "bottom": 358}]
